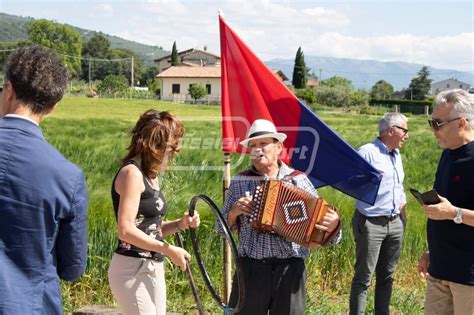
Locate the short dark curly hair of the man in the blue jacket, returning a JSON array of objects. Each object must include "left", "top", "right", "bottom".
[{"left": 5, "top": 45, "right": 68, "bottom": 114}]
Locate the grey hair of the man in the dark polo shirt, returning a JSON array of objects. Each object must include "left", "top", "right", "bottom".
[{"left": 435, "top": 89, "right": 474, "bottom": 129}]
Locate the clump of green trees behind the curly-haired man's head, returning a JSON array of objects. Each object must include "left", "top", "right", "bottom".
[{"left": 0, "top": 19, "right": 157, "bottom": 94}]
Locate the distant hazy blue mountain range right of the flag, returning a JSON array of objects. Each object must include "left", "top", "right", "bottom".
[{"left": 266, "top": 56, "right": 474, "bottom": 90}]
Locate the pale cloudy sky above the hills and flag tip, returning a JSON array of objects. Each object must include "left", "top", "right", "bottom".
[{"left": 0, "top": 0, "right": 474, "bottom": 72}]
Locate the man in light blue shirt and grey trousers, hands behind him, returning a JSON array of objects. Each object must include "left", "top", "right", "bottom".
[{"left": 350, "top": 113, "right": 409, "bottom": 314}]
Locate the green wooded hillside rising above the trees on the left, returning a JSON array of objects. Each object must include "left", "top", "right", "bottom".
[{"left": 0, "top": 12, "right": 170, "bottom": 64}]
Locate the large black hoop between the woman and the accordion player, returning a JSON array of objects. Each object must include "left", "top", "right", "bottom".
[{"left": 188, "top": 195, "right": 245, "bottom": 314}]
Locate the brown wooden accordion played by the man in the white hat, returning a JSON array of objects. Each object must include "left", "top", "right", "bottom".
[{"left": 249, "top": 180, "right": 335, "bottom": 249}]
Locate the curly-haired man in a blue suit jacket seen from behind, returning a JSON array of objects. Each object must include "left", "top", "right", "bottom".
[{"left": 0, "top": 46, "right": 87, "bottom": 315}]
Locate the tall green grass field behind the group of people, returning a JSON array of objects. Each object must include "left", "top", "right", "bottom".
[{"left": 42, "top": 96, "right": 441, "bottom": 314}]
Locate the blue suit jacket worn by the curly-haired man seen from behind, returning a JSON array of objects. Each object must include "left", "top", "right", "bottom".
[{"left": 0, "top": 116, "right": 87, "bottom": 315}]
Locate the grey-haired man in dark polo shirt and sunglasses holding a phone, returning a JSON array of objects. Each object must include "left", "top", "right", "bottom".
[{"left": 418, "top": 89, "right": 474, "bottom": 314}]
